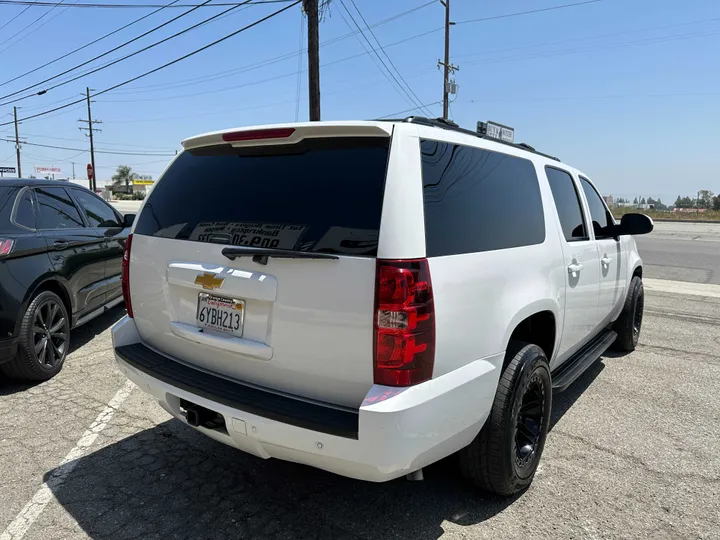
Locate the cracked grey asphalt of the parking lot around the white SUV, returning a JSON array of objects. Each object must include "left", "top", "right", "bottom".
[{"left": 0, "top": 292, "right": 720, "bottom": 540}]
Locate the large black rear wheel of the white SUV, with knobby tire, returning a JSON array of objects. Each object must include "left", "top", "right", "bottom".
[{"left": 458, "top": 342, "right": 552, "bottom": 496}]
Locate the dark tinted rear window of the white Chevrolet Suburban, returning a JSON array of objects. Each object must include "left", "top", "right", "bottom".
[{"left": 135, "top": 138, "right": 389, "bottom": 256}]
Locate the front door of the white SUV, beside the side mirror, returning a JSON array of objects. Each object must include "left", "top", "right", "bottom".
[{"left": 579, "top": 176, "right": 627, "bottom": 326}]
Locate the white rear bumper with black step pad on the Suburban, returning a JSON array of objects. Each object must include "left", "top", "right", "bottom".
[{"left": 112, "top": 317, "right": 502, "bottom": 482}]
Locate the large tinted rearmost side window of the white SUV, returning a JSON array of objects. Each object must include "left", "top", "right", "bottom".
[{"left": 421, "top": 141, "right": 545, "bottom": 257}]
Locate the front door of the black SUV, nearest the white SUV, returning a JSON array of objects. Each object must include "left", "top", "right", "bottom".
[{"left": 71, "top": 188, "right": 130, "bottom": 302}]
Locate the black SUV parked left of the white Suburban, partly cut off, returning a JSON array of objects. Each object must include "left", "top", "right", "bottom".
[{"left": 0, "top": 179, "right": 135, "bottom": 380}]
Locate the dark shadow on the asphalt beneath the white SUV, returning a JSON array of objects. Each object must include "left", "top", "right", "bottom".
[{"left": 45, "top": 356, "right": 605, "bottom": 540}]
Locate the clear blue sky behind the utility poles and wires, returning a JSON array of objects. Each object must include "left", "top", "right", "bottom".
[{"left": 0, "top": 0, "right": 720, "bottom": 202}]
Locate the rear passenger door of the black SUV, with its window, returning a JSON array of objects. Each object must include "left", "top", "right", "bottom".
[{"left": 35, "top": 186, "right": 107, "bottom": 319}]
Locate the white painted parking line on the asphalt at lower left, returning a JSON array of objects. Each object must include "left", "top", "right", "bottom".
[{"left": 0, "top": 381, "right": 135, "bottom": 540}]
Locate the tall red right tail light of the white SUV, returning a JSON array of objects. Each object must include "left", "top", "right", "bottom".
[{"left": 375, "top": 259, "right": 435, "bottom": 386}]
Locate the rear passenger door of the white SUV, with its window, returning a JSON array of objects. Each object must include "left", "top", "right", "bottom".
[{"left": 545, "top": 167, "right": 600, "bottom": 368}]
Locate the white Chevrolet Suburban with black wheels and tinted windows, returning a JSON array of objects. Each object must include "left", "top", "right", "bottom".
[{"left": 112, "top": 117, "right": 653, "bottom": 495}]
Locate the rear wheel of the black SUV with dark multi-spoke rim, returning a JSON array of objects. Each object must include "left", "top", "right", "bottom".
[{"left": 0, "top": 291, "right": 70, "bottom": 381}]
